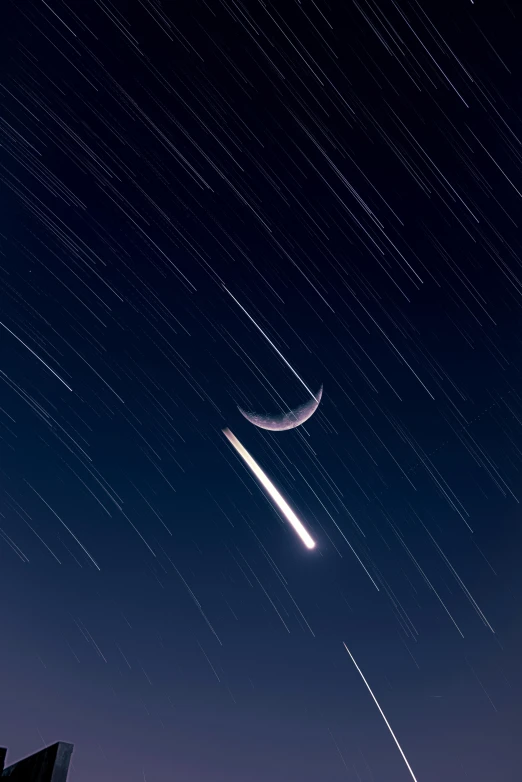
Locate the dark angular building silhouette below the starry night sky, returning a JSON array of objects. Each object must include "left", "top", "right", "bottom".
[{"left": 0, "top": 741, "right": 74, "bottom": 782}]
